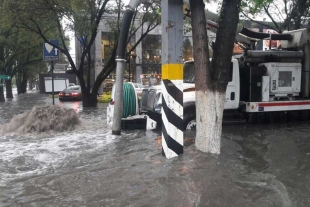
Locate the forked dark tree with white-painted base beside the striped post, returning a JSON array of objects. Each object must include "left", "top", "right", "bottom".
[{"left": 190, "top": 0, "right": 241, "bottom": 154}]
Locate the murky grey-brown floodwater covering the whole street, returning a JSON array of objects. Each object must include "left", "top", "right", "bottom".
[{"left": 0, "top": 92, "right": 310, "bottom": 207}]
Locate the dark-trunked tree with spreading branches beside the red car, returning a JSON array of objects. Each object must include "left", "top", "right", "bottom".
[{"left": 9, "top": 0, "right": 159, "bottom": 107}]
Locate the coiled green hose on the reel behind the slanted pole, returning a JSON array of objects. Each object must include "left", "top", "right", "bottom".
[{"left": 122, "top": 83, "right": 136, "bottom": 118}]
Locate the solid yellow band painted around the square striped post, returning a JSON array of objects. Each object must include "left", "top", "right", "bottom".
[{"left": 161, "top": 63, "right": 183, "bottom": 80}]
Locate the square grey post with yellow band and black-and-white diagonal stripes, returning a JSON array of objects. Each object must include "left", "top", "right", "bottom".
[{"left": 161, "top": 0, "right": 184, "bottom": 159}]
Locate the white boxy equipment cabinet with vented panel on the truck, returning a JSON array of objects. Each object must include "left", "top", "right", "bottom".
[{"left": 260, "top": 63, "right": 301, "bottom": 97}]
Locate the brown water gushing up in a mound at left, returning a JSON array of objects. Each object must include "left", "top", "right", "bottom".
[{"left": 0, "top": 106, "right": 80, "bottom": 135}]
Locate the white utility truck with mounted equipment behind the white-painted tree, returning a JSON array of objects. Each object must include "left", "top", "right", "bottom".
[{"left": 141, "top": 25, "right": 310, "bottom": 130}]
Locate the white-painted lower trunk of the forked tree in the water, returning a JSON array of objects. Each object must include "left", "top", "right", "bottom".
[{"left": 195, "top": 91, "right": 225, "bottom": 154}]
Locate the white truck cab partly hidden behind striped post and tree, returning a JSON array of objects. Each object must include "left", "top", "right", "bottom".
[{"left": 141, "top": 58, "right": 240, "bottom": 130}]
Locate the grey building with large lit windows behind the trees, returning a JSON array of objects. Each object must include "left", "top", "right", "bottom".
[{"left": 76, "top": 10, "right": 247, "bottom": 93}]
